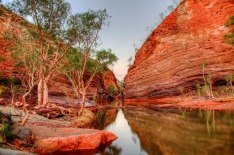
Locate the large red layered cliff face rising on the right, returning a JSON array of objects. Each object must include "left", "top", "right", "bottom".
[{"left": 124, "top": 0, "right": 234, "bottom": 101}]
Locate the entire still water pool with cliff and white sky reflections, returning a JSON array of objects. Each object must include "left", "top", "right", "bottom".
[{"left": 95, "top": 109, "right": 234, "bottom": 155}]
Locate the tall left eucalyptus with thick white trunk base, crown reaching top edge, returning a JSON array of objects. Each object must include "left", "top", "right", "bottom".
[{"left": 8, "top": 0, "right": 71, "bottom": 107}]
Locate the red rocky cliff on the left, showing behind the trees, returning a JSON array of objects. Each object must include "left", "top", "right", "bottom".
[{"left": 0, "top": 6, "right": 118, "bottom": 100}]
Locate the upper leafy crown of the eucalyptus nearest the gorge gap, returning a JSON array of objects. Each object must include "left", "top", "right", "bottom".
[{"left": 67, "top": 10, "right": 110, "bottom": 46}]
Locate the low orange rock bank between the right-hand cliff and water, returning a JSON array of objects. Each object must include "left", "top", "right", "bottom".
[{"left": 124, "top": 96, "right": 234, "bottom": 111}]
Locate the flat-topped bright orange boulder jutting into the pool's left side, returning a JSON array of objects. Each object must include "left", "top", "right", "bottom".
[{"left": 37, "top": 129, "right": 117, "bottom": 153}]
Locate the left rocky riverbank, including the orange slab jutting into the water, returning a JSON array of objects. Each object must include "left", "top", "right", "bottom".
[{"left": 0, "top": 105, "right": 117, "bottom": 154}]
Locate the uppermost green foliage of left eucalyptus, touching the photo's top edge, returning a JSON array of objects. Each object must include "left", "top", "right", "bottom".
[{"left": 7, "top": 0, "right": 71, "bottom": 38}]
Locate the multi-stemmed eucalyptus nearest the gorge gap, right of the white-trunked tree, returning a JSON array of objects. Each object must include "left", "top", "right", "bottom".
[{"left": 64, "top": 10, "right": 117, "bottom": 114}]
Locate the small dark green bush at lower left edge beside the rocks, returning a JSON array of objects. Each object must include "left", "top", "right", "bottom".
[{"left": 0, "top": 122, "right": 13, "bottom": 143}]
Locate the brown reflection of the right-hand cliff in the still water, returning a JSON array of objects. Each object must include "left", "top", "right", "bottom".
[{"left": 123, "top": 110, "right": 234, "bottom": 155}]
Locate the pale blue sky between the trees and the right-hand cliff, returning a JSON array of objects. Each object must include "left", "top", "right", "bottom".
[{"left": 2, "top": 0, "right": 179, "bottom": 80}]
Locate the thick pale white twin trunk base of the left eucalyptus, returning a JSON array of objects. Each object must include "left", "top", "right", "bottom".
[{"left": 38, "top": 79, "right": 49, "bottom": 107}]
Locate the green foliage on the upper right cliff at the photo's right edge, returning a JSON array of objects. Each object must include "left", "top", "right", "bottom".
[{"left": 223, "top": 15, "right": 234, "bottom": 46}]
